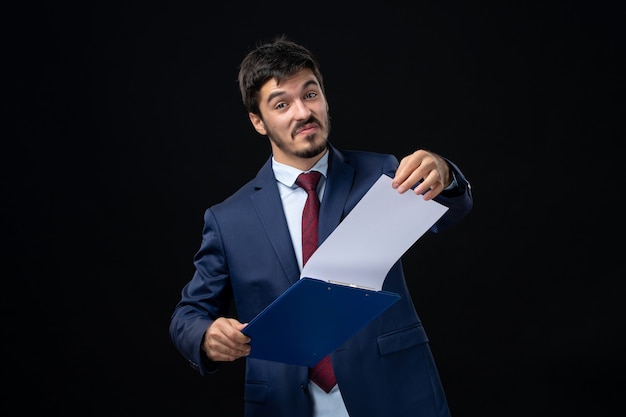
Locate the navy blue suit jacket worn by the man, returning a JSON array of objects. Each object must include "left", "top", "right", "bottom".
[{"left": 170, "top": 146, "right": 472, "bottom": 417}]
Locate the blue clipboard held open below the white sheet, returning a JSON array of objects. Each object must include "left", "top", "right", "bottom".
[{"left": 243, "top": 277, "right": 400, "bottom": 367}]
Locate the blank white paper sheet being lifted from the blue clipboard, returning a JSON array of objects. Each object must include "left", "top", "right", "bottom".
[{"left": 301, "top": 174, "right": 448, "bottom": 291}]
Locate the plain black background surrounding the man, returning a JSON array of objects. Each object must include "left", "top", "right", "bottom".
[{"left": 0, "top": 1, "right": 626, "bottom": 417}]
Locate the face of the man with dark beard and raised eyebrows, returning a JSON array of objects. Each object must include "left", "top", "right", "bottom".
[{"left": 249, "top": 69, "right": 330, "bottom": 170}]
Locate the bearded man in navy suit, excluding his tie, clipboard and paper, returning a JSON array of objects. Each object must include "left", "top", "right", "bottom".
[{"left": 170, "top": 37, "right": 472, "bottom": 417}]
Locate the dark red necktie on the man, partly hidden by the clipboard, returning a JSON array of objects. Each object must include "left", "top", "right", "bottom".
[{"left": 296, "top": 171, "right": 337, "bottom": 392}]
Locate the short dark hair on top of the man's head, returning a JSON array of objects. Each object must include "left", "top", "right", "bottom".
[{"left": 238, "top": 35, "right": 324, "bottom": 115}]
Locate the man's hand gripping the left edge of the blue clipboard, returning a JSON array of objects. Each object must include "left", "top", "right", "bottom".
[{"left": 202, "top": 317, "right": 250, "bottom": 362}]
